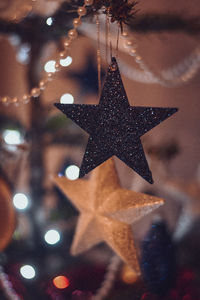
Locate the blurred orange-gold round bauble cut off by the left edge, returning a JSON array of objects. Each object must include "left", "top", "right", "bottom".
[{"left": 0, "top": 177, "right": 16, "bottom": 251}]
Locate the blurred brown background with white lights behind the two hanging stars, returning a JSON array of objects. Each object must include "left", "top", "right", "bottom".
[{"left": 0, "top": 0, "right": 200, "bottom": 300}]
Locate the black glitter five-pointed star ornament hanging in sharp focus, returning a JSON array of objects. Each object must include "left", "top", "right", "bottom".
[{"left": 55, "top": 57, "right": 177, "bottom": 183}]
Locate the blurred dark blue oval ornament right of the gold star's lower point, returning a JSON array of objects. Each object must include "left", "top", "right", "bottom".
[{"left": 141, "top": 221, "right": 176, "bottom": 294}]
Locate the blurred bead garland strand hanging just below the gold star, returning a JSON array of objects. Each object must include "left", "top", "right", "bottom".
[{"left": 92, "top": 255, "right": 121, "bottom": 300}]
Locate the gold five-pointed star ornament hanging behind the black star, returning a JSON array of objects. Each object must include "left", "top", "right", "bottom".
[{"left": 54, "top": 159, "right": 164, "bottom": 273}]
